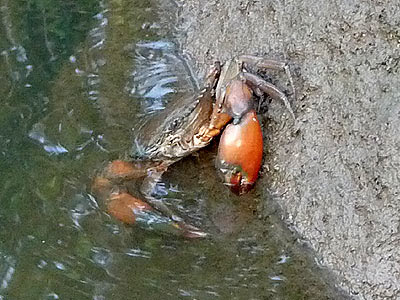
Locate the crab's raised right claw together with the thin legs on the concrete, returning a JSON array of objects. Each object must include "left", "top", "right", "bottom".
[{"left": 209, "top": 55, "right": 295, "bottom": 194}]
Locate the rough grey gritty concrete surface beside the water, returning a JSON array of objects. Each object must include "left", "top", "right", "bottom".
[{"left": 179, "top": 0, "right": 400, "bottom": 299}]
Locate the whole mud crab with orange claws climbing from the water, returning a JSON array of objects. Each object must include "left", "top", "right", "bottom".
[{"left": 93, "top": 55, "right": 294, "bottom": 237}]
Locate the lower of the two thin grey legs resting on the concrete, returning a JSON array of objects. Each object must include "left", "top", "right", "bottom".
[{"left": 241, "top": 72, "right": 295, "bottom": 119}]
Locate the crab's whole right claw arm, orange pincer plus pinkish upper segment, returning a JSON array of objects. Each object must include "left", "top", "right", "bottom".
[{"left": 209, "top": 78, "right": 263, "bottom": 195}]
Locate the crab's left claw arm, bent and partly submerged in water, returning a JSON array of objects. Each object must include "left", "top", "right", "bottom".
[{"left": 92, "top": 160, "right": 207, "bottom": 238}]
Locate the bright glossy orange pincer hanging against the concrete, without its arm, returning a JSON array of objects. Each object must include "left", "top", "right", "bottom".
[{"left": 217, "top": 110, "right": 263, "bottom": 195}]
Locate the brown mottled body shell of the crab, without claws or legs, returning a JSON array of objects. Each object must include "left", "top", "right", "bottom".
[{"left": 131, "top": 69, "right": 219, "bottom": 163}]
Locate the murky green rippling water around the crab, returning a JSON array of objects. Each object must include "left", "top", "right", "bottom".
[{"left": 0, "top": 0, "right": 346, "bottom": 300}]
